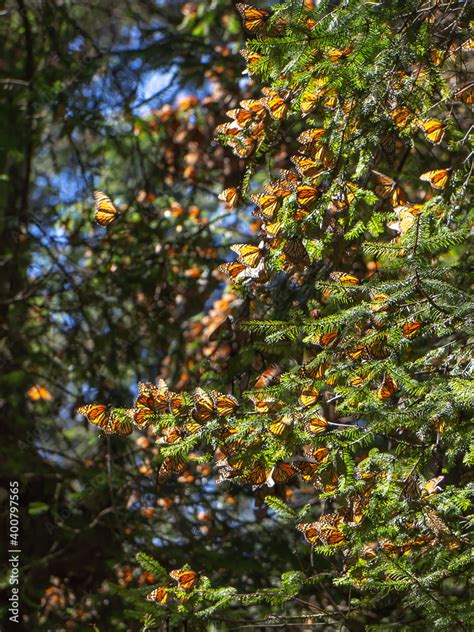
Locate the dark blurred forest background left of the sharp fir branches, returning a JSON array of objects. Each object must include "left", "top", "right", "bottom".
[{"left": 0, "top": 0, "right": 278, "bottom": 630}]
